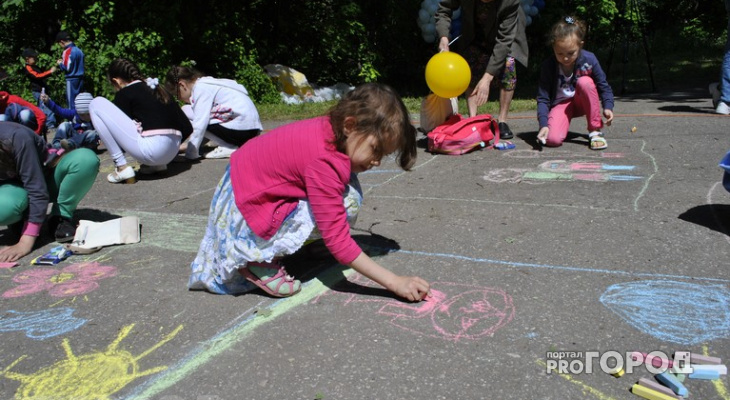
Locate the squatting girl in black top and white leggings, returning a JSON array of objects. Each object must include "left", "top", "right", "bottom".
[{"left": 89, "top": 58, "right": 193, "bottom": 183}]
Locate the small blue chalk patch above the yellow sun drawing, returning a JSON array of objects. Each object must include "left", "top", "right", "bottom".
[{"left": 0, "top": 307, "right": 86, "bottom": 340}]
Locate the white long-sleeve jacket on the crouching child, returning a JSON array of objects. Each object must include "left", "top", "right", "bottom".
[{"left": 185, "top": 76, "right": 262, "bottom": 159}]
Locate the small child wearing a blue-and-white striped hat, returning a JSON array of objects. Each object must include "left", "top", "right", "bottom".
[{"left": 41, "top": 92, "right": 100, "bottom": 151}]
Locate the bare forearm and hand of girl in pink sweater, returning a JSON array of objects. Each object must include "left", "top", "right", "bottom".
[{"left": 349, "top": 252, "right": 430, "bottom": 301}]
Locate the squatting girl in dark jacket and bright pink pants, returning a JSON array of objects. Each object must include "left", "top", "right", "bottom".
[{"left": 537, "top": 17, "right": 613, "bottom": 150}]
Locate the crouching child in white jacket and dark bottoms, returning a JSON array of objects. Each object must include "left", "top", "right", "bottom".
[{"left": 166, "top": 65, "right": 262, "bottom": 160}]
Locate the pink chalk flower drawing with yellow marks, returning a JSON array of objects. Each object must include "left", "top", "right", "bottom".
[{"left": 2, "top": 262, "right": 117, "bottom": 299}]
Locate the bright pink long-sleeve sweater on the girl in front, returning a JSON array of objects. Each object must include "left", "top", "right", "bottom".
[{"left": 231, "top": 117, "right": 362, "bottom": 264}]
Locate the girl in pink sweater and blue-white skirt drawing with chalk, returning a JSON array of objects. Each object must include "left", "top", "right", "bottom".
[{"left": 188, "top": 83, "right": 429, "bottom": 301}]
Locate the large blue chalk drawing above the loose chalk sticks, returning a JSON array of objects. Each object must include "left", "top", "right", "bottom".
[{"left": 600, "top": 280, "right": 730, "bottom": 345}]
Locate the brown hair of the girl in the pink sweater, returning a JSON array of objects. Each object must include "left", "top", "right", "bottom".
[{"left": 327, "top": 83, "right": 416, "bottom": 171}]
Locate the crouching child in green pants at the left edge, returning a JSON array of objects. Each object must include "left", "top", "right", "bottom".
[{"left": 0, "top": 122, "right": 99, "bottom": 262}]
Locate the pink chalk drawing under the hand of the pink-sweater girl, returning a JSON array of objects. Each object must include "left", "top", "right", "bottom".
[{"left": 312, "top": 274, "right": 515, "bottom": 342}]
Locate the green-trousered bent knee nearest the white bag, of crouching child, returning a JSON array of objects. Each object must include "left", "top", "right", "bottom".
[{"left": 46, "top": 148, "right": 99, "bottom": 219}]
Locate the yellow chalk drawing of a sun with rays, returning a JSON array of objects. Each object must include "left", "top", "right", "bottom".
[{"left": 1, "top": 324, "right": 182, "bottom": 400}]
